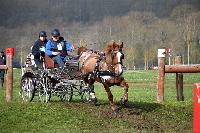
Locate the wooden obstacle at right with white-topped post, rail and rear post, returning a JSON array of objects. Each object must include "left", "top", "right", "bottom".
[{"left": 157, "top": 49, "right": 200, "bottom": 102}]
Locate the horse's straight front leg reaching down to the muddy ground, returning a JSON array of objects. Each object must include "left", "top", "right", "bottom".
[{"left": 104, "top": 85, "right": 117, "bottom": 113}]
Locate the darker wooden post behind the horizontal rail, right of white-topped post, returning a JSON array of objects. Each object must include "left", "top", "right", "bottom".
[{"left": 175, "top": 56, "right": 184, "bottom": 101}]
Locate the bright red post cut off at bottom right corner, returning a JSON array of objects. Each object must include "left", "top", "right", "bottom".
[{"left": 193, "top": 83, "right": 200, "bottom": 133}]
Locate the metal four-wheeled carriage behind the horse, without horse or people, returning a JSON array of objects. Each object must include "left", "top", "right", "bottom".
[{"left": 20, "top": 51, "right": 96, "bottom": 102}]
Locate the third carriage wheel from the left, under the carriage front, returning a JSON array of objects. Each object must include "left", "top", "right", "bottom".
[{"left": 60, "top": 86, "right": 73, "bottom": 102}]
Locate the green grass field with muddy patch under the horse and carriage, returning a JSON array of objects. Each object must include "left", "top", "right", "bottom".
[{"left": 0, "top": 70, "right": 197, "bottom": 133}]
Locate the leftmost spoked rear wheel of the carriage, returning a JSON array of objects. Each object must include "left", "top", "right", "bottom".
[{"left": 20, "top": 76, "right": 35, "bottom": 102}]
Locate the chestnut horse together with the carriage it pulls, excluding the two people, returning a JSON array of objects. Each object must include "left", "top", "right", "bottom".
[{"left": 20, "top": 42, "right": 128, "bottom": 112}]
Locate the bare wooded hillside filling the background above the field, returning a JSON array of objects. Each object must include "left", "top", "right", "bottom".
[{"left": 0, "top": 0, "right": 200, "bottom": 69}]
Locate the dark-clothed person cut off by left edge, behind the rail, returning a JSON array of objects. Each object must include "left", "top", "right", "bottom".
[{"left": 0, "top": 49, "right": 6, "bottom": 88}]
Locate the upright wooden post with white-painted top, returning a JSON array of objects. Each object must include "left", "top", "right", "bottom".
[{"left": 157, "top": 49, "right": 165, "bottom": 102}]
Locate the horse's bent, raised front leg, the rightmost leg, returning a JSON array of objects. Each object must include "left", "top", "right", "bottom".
[{"left": 120, "top": 80, "right": 129, "bottom": 105}]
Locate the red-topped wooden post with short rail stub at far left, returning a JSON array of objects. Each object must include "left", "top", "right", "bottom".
[{"left": 0, "top": 48, "right": 14, "bottom": 102}]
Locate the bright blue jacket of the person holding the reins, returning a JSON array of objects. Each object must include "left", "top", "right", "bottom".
[{"left": 45, "top": 39, "right": 73, "bottom": 57}]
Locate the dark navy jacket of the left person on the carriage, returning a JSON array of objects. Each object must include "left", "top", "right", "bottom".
[{"left": 32, "top": 39, "right": 47, "bottom": 59}]
